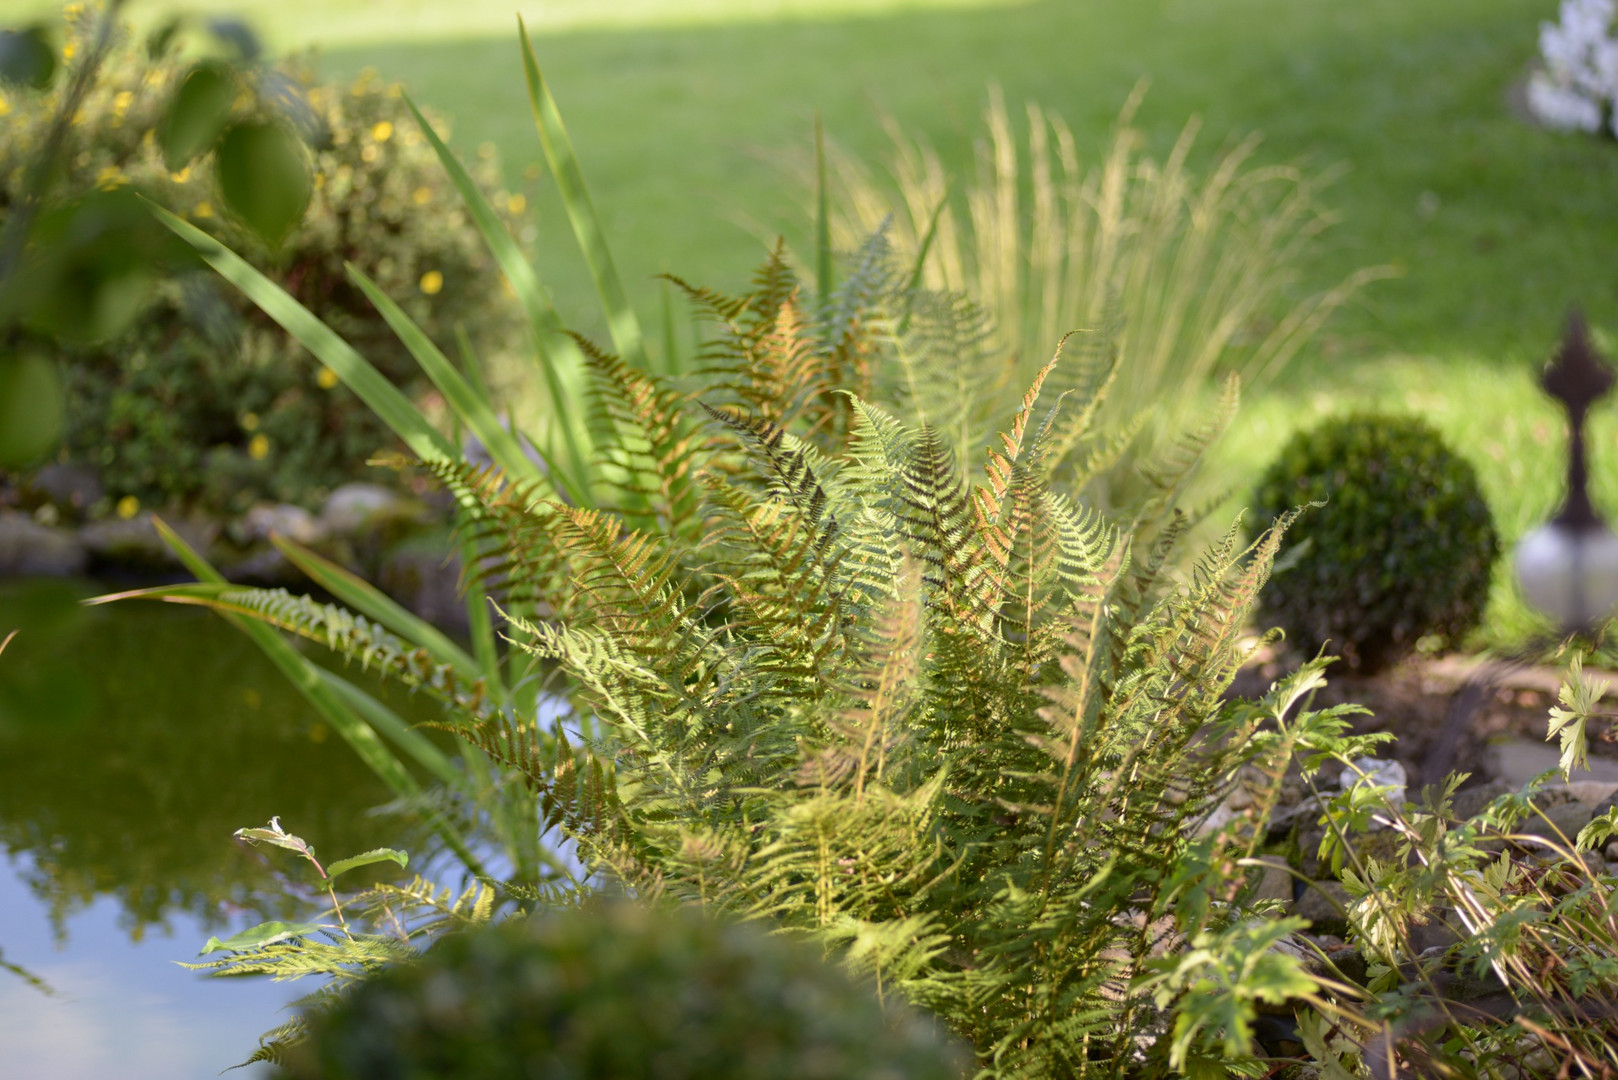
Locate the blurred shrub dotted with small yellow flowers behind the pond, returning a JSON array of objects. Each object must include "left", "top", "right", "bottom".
[{"left": 0, "top": 5, "right": 511, "bottom": 510}]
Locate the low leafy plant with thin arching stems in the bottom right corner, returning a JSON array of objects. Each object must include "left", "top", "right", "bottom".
[{"left": 1299, "top": 657, "right": 1618, "bottom": 1080}]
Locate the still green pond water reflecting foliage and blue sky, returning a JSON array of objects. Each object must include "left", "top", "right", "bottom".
[{"left": 0, "top": 580, "right": 443, "bottom": 1080}]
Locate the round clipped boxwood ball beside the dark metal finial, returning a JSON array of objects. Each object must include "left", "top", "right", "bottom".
[{"left": 1254, "top": 413, "right": 1500, "bottom": 674}]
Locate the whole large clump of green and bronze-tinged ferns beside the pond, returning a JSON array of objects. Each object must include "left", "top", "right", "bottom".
[{"left": 177, "top": 244, "right": 1359, "bottom": 1075}]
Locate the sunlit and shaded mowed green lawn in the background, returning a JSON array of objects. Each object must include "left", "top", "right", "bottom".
[{"left": 12, "top": 0, "right": 1618, "bottom": 636}]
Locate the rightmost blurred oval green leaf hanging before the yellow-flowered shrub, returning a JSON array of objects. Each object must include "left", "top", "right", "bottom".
[{"left": 214, "top": 120, "right": 314, "bottom": 246}]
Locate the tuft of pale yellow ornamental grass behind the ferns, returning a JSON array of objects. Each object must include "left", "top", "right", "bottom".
[{"left": 821, "top": 84, "right": 1390, "bottom": 424}]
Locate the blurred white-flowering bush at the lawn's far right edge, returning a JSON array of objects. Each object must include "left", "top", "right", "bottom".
[{"left": 1527, "top": 0, "right": 1618, "bottom": 138}]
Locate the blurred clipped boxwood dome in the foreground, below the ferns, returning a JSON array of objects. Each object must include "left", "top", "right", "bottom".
[{"left": 288, "top": 902, "right": 971, "bottom": 1080}]
